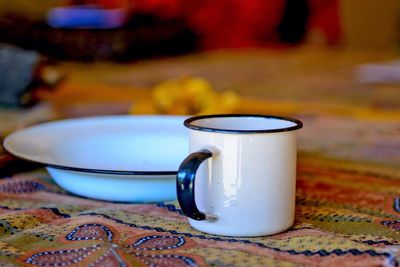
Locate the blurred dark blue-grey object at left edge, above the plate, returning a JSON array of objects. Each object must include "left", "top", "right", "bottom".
[{"left": 0, "top": 45, "right": 40, "bottom": 107}]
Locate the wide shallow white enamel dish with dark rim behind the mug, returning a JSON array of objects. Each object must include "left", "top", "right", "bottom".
[{"left": 3, "top": 115, "right": 188, "bottom": 202}]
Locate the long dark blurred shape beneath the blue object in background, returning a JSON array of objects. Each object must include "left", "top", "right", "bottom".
[{"left": 0, "top": 14, "right": 196, "bottom": 61}]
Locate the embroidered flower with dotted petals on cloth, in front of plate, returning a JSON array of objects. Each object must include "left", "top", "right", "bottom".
[{"left": 25, "top": 223, "right": 198, "bottom": 267}]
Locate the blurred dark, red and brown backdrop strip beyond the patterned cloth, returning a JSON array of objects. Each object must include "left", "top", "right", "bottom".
[{"left": 0, "top": 0, "right": 400, "bottom": 57}]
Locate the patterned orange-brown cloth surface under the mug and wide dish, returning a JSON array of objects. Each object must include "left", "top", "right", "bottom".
[{"left": 0, "top": 47, "right": 400, "bottom": 266}]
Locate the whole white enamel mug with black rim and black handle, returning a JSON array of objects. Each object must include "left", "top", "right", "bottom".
[{"left": 177, "top": 114, "right": 303, "bottom": 237}]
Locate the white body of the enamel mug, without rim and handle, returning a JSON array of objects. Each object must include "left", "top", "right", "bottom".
[{"left": 189, "top": 130, "right": 297, "bottom": 236}]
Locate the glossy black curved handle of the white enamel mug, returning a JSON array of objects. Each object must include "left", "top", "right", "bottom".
[{"left": 176, "top": 149, "right": 216, "bottom": 221}]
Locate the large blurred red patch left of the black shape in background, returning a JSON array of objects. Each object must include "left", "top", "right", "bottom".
[{"left": 111, "top": 0, "right": 285, "bottom": 49}]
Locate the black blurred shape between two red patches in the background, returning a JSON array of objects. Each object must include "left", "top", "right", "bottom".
[{"left": 278, "top": 0, "right": 310, "bottom": 43}]
